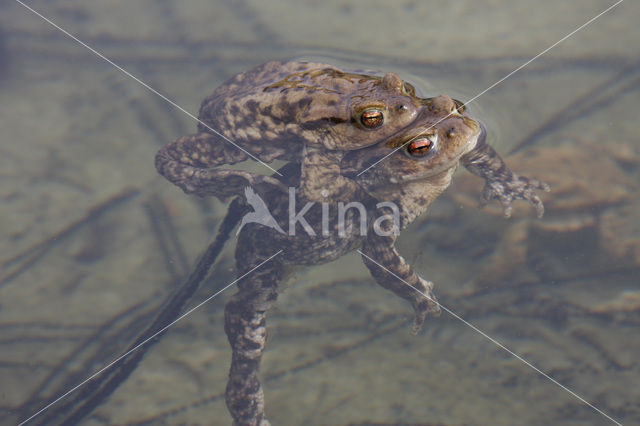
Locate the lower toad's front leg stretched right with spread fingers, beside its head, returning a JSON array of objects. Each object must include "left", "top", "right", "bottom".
[{"left": 460, "top": 129, "right": 550, "bottom": 218}]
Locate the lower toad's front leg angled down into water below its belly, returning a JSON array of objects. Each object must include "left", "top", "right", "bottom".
[{"left": 361, "top": 233, "right": 440, "bottom": 334}]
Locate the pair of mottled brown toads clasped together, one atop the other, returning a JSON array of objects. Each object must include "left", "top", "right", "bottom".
[{"left": 156, "top": 58, "right": 547, "bottom": 425}]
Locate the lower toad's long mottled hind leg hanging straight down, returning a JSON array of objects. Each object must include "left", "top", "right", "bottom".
[{"left": 224, "top": 253, "right": 283, "bottom": 426}]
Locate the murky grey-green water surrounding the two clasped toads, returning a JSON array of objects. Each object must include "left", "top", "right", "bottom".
[{"left": 0, "top": 0, "right": 640, "bottom": 425}]
